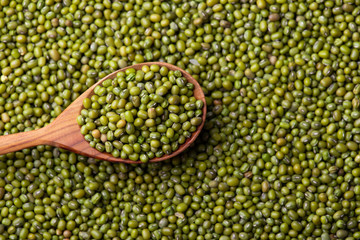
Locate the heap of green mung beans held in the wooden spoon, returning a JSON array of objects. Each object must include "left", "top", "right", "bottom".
[{"left": 77, "top": 64, "right": 204, "bottom": 163}]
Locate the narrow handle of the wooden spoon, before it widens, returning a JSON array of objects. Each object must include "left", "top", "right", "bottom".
[{"left": 0, "top": 127, "right": 47, "bottom": 154}]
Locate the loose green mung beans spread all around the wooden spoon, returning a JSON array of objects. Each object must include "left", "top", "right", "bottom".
[{"left": 0, "top": 0, "right": 360, "bottom": 240}]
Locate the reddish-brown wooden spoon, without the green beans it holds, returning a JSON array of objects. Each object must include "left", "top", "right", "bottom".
[{"left": 0, "top": 62, "right": 206, "bottom": 163}]
